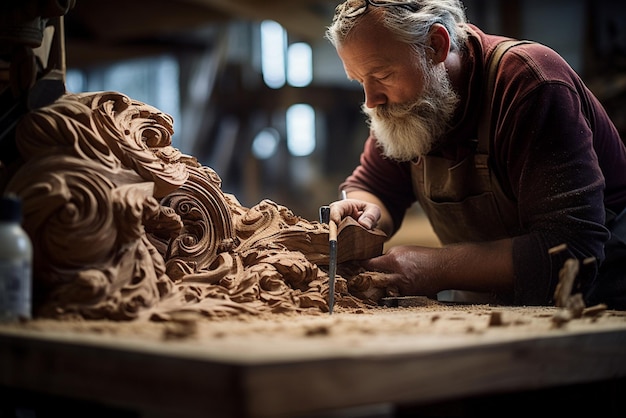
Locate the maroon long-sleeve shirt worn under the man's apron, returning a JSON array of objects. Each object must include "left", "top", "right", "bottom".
[{"left": 340, "top": 26, "right": 626, "bottom": 305}]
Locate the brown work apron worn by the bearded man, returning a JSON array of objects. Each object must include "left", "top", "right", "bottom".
[{"left": 411, "top": 138, "right": 520, "bottom": 304}]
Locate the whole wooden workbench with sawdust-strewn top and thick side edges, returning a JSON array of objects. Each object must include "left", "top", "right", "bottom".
[{"left": 0, "top": 304, "right": 626, "bottom": 417}]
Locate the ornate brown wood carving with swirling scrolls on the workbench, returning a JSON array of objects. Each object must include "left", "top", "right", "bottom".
[{"left": 6, "top": 92, "right": 385, "bottom": 320}]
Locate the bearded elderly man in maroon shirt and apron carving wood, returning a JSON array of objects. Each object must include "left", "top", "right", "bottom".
[{"left": 326, "top": 0, "right": 626, "bottom": 309}]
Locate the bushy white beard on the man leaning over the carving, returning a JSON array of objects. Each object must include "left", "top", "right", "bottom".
[{"left": 362, "top": 63, "right": 459, "bottom": 161}]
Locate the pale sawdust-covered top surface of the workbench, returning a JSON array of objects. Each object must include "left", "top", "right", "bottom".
[{"left": 3, "top": 298, "right": 626, "bottom": 354}]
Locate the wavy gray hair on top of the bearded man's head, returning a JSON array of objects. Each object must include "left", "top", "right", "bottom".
[{"left": 326, "top": 0, "right": 468, "bottom": 51}]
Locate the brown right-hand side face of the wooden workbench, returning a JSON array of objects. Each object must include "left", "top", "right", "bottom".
[{"left": 244, "top": 331, "right": 626, "bottom": 417}]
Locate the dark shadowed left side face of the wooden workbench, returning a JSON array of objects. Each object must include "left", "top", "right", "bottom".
[{"left": 0, "top": 335, "right": 242, "bottom": 417}]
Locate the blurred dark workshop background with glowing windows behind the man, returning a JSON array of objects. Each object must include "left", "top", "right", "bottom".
[{"left": 58, "top": 0, "right": 626, "bottom": 219}]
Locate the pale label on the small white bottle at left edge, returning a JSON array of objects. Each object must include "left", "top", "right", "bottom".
[{"left": 0, "top": 260, "right": 31, "bottom": 321}]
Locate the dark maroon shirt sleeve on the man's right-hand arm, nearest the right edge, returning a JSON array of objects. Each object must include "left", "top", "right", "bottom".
[{"left": 494, "top": 83, "right": 609, "bottom": 305}]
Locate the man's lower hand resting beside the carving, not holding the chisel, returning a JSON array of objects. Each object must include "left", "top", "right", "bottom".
[{"left": 360, "top": 245, "right": 443, "bottom": 298}]
